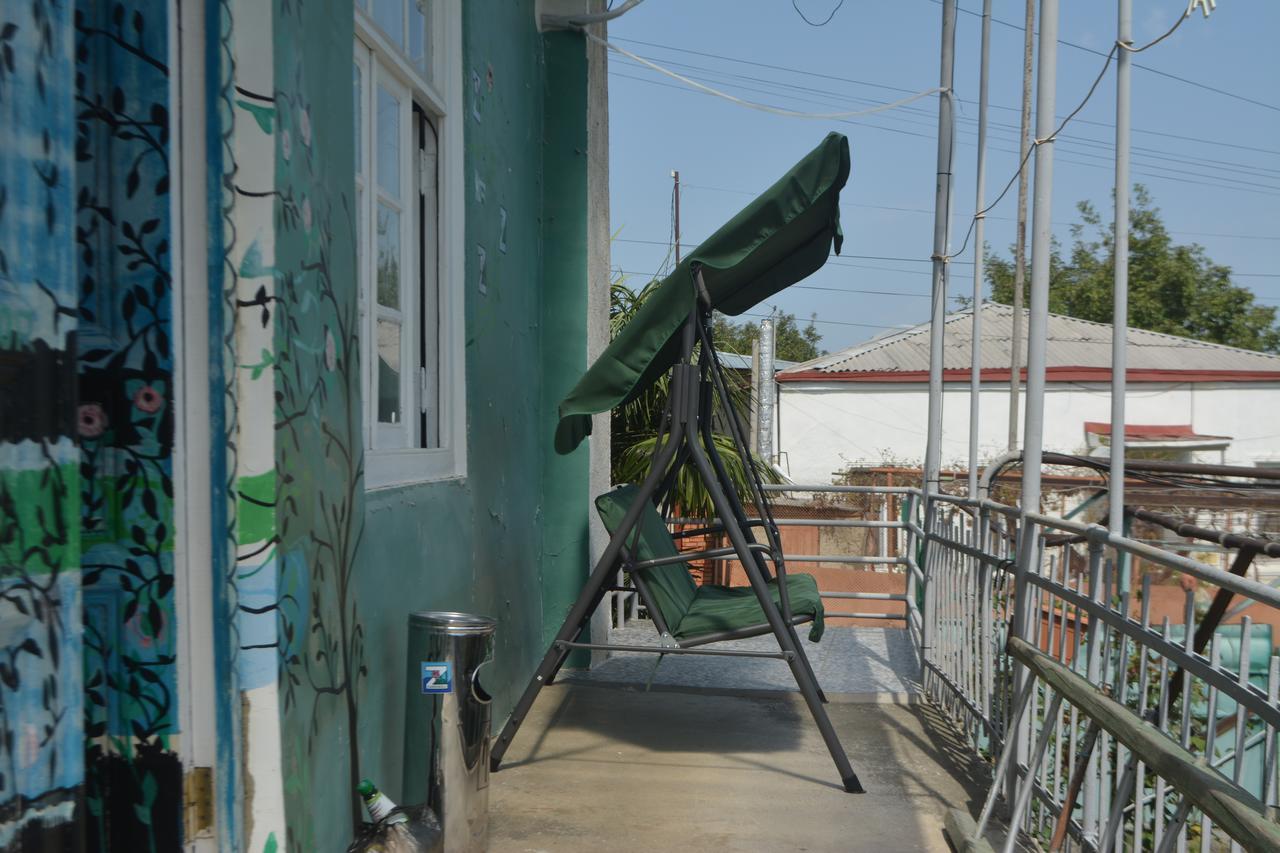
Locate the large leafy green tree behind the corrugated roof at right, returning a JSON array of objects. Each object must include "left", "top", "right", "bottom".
[{"left": 986, "top": 184, "right": 1280, "bottom": 352}]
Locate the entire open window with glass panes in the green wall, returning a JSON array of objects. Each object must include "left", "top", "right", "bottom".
[{"left": 352, "top": 0, "right": 465, "bottom": 488}]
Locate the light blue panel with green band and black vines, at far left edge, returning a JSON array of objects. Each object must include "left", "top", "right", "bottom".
[{"left": 0, "top": 0, "right": 83, "bottom": 850}]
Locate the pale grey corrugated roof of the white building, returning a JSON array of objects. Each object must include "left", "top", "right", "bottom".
[{"left": 781, "top": 302, "right": 1280, "bottom": 375}]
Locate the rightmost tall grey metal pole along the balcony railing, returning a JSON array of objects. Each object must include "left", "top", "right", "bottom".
[{"left": 1107, "top": 0, "right": 1133, "bottom": 593}]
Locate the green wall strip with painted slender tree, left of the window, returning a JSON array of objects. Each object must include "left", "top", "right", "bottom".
[{"left": 273, "top": 0, "right": 366, "bottom": 850}]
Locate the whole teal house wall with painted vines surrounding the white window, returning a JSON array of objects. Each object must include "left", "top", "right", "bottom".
[{"left": 203, "top": 0, "right": 588, "bottom": 850}]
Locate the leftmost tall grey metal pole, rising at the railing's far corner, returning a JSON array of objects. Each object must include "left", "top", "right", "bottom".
[{"left": 924, "top": 0, "right": 956, "bottom": 494}]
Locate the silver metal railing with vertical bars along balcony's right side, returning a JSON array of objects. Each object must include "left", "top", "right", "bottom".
[{"left": 915, "top": 494, "right": 1280, "bottom": 850}]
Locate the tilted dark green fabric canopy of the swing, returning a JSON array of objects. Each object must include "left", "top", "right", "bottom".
[{"left": 556, "top": 133, "right": 849, "bottom": 453}]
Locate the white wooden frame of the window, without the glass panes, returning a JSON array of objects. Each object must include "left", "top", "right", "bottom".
[{"left": 355, "top": 0, "right": 466, "bottom": 489}]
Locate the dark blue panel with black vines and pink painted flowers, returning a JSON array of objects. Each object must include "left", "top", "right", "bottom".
[{"left": 74, "top": 0, "right": 182, "bottom": 852}]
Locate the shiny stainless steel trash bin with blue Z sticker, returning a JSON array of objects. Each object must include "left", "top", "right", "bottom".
[{"left": 403, "top": 611, "right": 498, "bottom": 853}]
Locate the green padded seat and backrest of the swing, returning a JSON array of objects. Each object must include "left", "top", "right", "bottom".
[{"left": 595, "top": 485, "right": 823, "bottom": 643}]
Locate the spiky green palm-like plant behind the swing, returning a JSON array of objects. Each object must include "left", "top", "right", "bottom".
[{"left": 609, "top": 275, "right": 780, "bottom": 517}]
